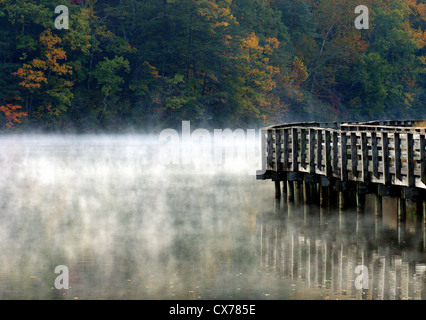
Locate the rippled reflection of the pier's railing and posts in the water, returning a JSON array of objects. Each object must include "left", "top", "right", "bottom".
[{"left": 259, "top": 190, "right": 426, "bottom": 300}]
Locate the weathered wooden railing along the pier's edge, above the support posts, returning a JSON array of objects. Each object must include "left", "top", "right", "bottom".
[{"left": 258, "top": 120, "right": 426, "bottom": 189}]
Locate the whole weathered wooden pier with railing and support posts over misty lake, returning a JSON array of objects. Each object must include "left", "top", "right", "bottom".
[{"left": 257, "top": 120, "right": 426, "bottom": 241}]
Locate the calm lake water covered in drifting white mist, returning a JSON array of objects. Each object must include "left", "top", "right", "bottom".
[{"left": 0, "top": 135, "right": 426, "bottom": 300}]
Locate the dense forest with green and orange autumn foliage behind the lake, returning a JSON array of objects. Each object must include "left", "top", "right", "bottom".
[{"left": 0, "top": 0, "right": 426, "bottom": 132}]
